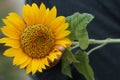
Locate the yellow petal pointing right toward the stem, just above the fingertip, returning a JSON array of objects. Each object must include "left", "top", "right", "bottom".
[{"left": 55, "top": 38, "right": 72, "bottom": 48}]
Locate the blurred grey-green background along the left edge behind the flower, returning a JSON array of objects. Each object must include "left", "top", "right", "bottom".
[{"left": 0, "top": 0, "right": 31, "bottom": 80}]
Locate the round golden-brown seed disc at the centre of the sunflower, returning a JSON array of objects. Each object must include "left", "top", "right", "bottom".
[{"left": 20, "top": 24, "right": 55, "bottom": 58}]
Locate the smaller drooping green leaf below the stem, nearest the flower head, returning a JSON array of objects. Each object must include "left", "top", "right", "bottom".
[{"left": 62, "top": 49, "right": 79, "bottom": 77}]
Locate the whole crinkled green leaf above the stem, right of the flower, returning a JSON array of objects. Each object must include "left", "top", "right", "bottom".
[{"left": 66, "top": 12, "right": 93, "bottom": 50}]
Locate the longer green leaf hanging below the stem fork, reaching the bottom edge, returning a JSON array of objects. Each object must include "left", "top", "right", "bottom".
[{"left": 73, "top": 50, "right": 94, "bottom": 80}]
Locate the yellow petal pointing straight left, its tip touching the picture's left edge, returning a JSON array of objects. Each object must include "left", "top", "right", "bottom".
[{"left": 0, "top": 38, "right": 20, "bottom": 48}]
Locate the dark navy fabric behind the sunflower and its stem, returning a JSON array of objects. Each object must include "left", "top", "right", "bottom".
[{"left": 27, "top": 0, "right": 120, "bottom": 80}]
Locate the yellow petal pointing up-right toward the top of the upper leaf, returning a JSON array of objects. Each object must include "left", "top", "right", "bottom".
[{"left": 50, "top": 16, "right": 65, "bottom": 31}]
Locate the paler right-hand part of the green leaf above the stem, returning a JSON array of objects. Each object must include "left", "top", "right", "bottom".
[{"left": 75, "top": 13, "right": 93, "bottom": 50}]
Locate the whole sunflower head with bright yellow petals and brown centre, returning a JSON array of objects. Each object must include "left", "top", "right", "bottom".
[{"left": 0, "top": 3, "right": 72, "bottom": 74}]
